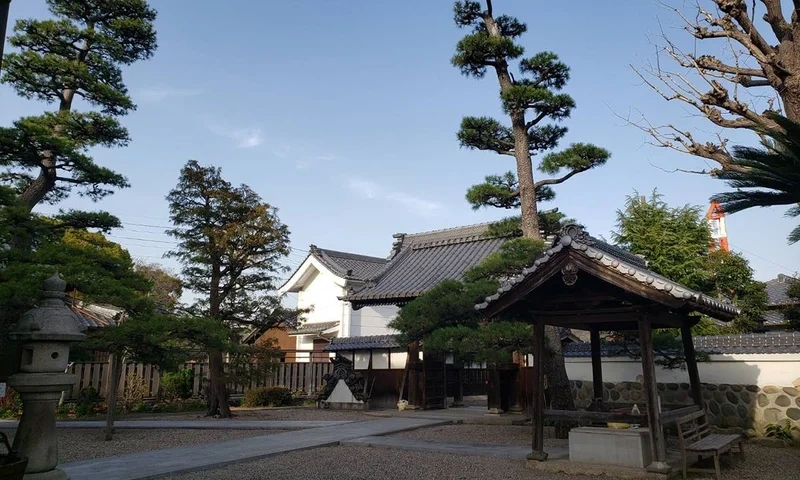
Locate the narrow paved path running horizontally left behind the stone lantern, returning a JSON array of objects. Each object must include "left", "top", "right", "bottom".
[{"left": 0, "top": 418, "right": 355, "bottom": 430}]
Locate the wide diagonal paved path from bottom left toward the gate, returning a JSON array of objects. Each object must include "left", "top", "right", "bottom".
[{"left": 59, "top": 418, "right": 452, "bottom": 480}]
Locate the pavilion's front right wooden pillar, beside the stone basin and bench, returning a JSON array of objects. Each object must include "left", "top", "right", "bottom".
[{"left": 639, "top": 315, "right": 671, "bottom": 473}]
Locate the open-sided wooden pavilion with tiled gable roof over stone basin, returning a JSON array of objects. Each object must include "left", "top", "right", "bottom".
[{"left": 475, "top": 225, "right": 739, "bottom": 473}]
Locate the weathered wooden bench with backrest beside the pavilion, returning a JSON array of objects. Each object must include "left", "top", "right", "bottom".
[{"left": 675, "top": 410, "right": 744, "bottom": 480}]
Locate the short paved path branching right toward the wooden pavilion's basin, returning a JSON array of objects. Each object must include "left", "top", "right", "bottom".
[{"left": 341, "top": 437, "right": 569, "bottom": 460}]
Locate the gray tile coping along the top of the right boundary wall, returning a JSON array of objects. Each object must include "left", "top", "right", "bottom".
[{"left": 563, "top": 332, "right": 800, "bottom": 357}]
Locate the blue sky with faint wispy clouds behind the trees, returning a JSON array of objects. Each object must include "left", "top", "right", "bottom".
[{"left": 0, "top": 0, "right": 800, "bottom": 280}]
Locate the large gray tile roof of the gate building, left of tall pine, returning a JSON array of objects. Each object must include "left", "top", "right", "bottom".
[{"left": 343, "top": 223, "right": 505, "bottom": 307}]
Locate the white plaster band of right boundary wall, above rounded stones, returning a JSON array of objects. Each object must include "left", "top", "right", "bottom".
[{"left": 565, "top": 354, "right": 800, "bottom": 387}]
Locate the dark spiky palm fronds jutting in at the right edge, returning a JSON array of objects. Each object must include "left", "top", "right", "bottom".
[{"left": 711, "top": 112, "right": 800, "bottom": 244}]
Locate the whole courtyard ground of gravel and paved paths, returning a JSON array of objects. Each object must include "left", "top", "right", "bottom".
[{"left": 0, "top": 407, "right": 800, "bottom": 480}]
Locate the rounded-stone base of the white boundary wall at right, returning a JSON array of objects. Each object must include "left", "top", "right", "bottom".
[{"left": 570, "top": 375, "right": 800, "bottom": 436}]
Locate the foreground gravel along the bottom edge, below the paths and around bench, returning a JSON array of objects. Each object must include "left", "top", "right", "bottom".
[{"left": 162, "top": 442, "right": 800, "bottom": 480}]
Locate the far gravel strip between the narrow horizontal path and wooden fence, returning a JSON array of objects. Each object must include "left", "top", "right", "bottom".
[{"left": 128, "top": 407, "right": 376, "bottom": 421}]
